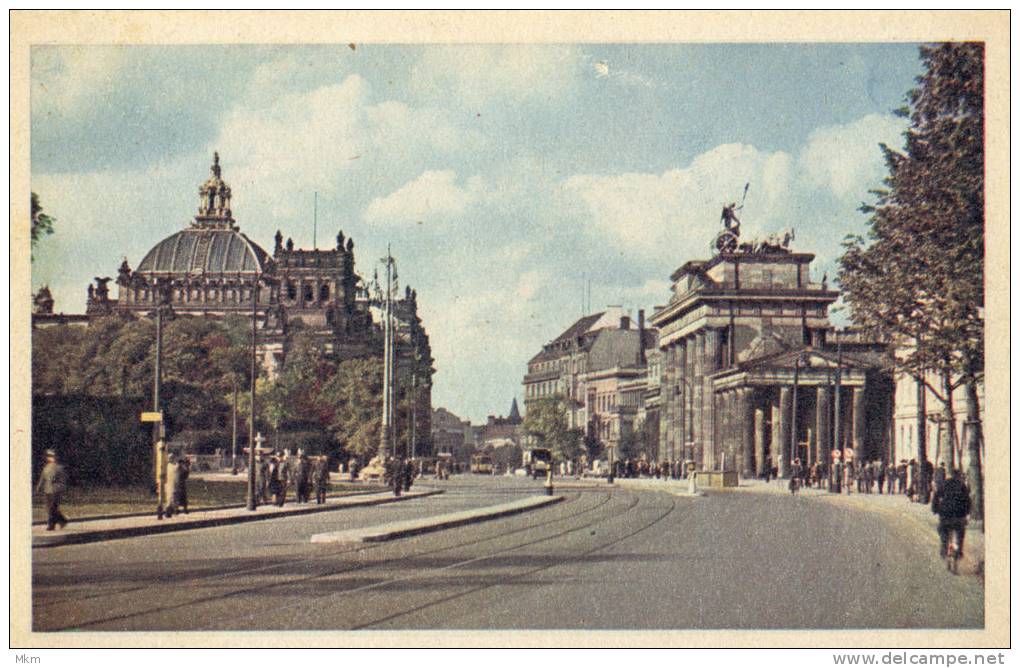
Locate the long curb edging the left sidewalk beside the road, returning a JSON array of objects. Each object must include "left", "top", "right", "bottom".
[{"left": 32, "top": 490, "right": 444, "bottom": 549}]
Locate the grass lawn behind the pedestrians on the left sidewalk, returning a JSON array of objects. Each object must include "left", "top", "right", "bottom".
[{"left": 32, "top": 479, "right": 383, "bottom": 522}]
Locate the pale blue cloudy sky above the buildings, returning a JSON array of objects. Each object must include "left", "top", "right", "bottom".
[{"left": 31, "top": 44, "right": 920, "bottom": 421}]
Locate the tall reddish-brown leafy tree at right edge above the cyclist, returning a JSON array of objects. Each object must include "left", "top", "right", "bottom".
[{"left": 838, "top": 43, "right": 984, "bottom": 517}]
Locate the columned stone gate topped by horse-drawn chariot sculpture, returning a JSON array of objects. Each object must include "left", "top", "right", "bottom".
[{"left": 652, "top": 208, "right": 893, "bottom": 476}]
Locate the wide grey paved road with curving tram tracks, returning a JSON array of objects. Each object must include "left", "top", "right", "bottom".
[{"left": 33, "top": 476, "right": 983, "bottom": 630}]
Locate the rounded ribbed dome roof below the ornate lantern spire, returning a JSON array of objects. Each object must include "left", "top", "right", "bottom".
[{"left": 137, "top": 227, "right": 269, "bottom": 274}]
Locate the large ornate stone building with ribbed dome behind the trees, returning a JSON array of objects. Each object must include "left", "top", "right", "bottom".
[{"left": 27, "top": 154, "right": 434, "bottom": 453}]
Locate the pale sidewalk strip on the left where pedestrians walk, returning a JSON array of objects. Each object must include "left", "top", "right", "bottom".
[{"left": 32, "top": 490, "right": 443, "bottom": 548}]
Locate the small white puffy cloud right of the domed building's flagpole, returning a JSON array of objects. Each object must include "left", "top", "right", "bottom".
[{"left": 365, "top": 169, "right": 485, "bottom": 223}]
